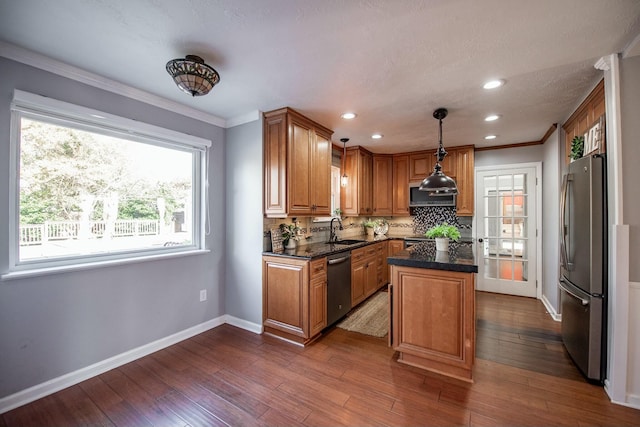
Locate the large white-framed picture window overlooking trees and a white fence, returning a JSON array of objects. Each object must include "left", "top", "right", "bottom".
[{"left": 9, "top": 90, "right": 210, "bottom": 270}]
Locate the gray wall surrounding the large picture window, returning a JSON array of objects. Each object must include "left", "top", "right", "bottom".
[{"left": 0, "top": 58, "right": 228, "bottom": 397}]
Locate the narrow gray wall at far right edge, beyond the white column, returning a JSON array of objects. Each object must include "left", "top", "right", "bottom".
[{"left": 620, "top": 56, "right": 640, "bottom": 282}]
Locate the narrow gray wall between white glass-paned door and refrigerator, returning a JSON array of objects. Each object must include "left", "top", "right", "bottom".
[{"left": 542, "top": 128, "right": 564, "bottom": 313}]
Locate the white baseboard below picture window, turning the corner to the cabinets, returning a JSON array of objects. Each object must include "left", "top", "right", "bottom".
[{"left": 0, "top": 315, "right": 238, "bottom": 414}]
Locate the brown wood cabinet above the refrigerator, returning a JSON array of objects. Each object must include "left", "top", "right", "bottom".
[{"left": 562, "top": 80, "right": 606, "bottom": 163}]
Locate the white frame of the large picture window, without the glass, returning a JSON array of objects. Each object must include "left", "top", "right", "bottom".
[{"left": 0, "top": 89, "right": 211, "bottom": 280}]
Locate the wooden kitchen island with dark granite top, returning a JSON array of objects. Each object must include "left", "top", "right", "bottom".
[{"left": 387, "top": 242, "right": 478, "bottom": 381}]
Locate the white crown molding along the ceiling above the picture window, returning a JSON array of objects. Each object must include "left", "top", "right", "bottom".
[{"left": 0, "top": 41, "right": 227, "bottom": 128}]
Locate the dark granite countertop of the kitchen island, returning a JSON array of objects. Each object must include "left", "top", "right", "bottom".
[{"left": 387, "top": 241, "right": 478, "bottom": 273}]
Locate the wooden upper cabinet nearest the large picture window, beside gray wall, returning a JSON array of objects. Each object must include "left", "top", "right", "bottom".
[{"left": 263, "top": 108, "right": 333, "bottom": 217}]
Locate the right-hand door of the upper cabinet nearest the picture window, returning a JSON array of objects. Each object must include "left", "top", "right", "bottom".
[{"left": 311, "top": 132, "right": 331, "bottom": 216}]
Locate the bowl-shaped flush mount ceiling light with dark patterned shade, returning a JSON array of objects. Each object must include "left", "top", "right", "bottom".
[{"left": 167, "top": 55, "right": 220, "bottom": 96}]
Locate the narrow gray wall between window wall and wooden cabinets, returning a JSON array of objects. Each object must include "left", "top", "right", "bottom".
[{"left": 225, "top": 119, "right": 263, "bottom": 326}]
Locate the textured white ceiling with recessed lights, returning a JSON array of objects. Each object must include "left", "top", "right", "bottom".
[{"left": 0, "top": 0, "right": 640, "bottom": 153}]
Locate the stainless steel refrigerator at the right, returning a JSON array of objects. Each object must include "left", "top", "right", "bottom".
[{"left": 560, "top": 154, "right": 607, "bottom": 382}]
